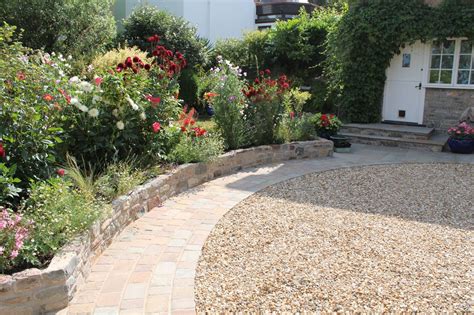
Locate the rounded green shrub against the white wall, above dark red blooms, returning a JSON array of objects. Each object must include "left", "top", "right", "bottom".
[{"left": 121, "top": 6, "right": 208, "bottom": 68}]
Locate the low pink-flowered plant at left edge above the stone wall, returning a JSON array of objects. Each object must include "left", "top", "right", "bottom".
[{"left": 0, "top": 208, "right": 33, "bottom": 273}]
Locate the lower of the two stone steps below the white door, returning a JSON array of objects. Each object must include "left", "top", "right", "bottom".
[{"left": 339, "top": 132, "right": 448, "bottom": 152}]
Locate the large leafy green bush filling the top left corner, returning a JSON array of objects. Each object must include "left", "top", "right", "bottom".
[{"left": 0, "top": 0, "right": 116, "bottom": 57}]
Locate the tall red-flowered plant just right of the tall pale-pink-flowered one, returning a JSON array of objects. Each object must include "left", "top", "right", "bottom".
[{"left": 242, "top": 69, "right": 290, "bottom": 145}]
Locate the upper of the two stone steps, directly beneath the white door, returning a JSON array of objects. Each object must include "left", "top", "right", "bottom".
[{"left": 341, "top": 123, "right": 434, "bottom": 140}]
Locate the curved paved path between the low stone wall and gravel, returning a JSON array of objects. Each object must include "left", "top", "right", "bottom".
[{"left": 60, "top": 145, "right": 474, "bottom": 314}]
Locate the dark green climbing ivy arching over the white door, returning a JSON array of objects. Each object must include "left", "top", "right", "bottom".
[{"left": 326, "top": 0, "right": 474, "bottom": 123}]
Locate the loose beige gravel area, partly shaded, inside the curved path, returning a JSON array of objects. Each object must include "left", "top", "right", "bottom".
[{"left": 195, "top": 164, "right": 474, "bottom": 313}]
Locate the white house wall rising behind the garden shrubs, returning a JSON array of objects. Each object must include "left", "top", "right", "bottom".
[{"left": 122, "top": 0, "right": 256, "bottom": 42}]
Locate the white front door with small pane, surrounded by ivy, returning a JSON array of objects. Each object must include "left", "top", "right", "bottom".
[{"left": 382, "top": 41, "right": 426, "bottom": 124}]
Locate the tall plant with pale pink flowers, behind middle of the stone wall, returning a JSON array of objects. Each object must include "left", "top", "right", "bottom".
[{"left": 204, "top": 59, "right": 249, "bottom": 150}]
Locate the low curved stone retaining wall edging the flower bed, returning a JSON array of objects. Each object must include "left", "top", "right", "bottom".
[{"left": 0, "top": 139, "right": 333, "bottom": 315}]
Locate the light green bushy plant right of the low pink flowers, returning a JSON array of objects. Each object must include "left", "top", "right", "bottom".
[{"left": 19, "top": 178, "right": 103, "bottom": 267}]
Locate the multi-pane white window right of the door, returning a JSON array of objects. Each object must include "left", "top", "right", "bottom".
[{"left": 428, "top": 39, "right": 474, "bottom": 87}]
